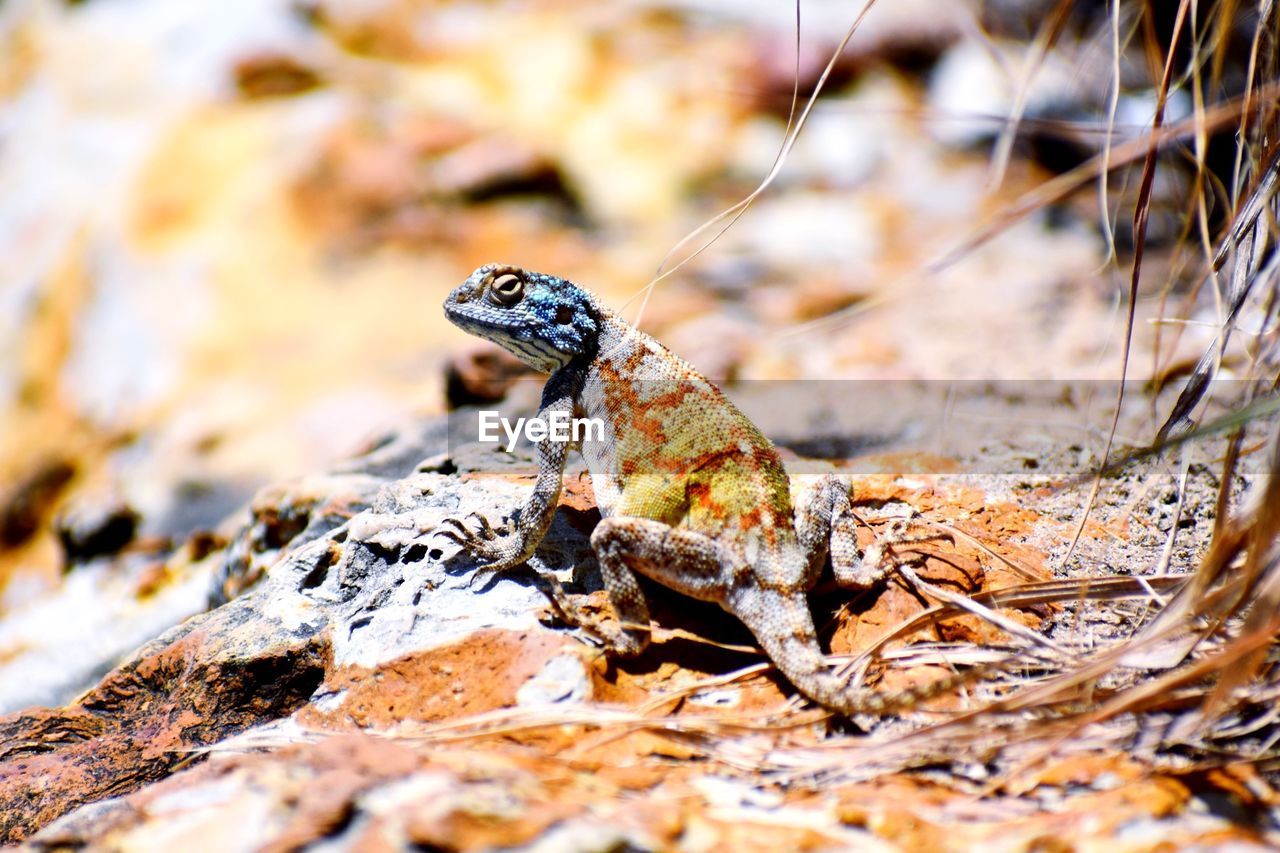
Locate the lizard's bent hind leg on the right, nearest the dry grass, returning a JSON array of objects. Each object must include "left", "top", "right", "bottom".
[{"left": 795, "top": 474, "right": 891, "bottom": 589}]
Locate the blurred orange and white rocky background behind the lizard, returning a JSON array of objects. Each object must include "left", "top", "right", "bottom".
[{"left": 0, "top": 0, "right": 1275, "bottom": 612}]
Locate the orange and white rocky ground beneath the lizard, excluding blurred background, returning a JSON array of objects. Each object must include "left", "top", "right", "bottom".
[{"left": 0, "top": 404, "right": 1263, "bottom": 849}]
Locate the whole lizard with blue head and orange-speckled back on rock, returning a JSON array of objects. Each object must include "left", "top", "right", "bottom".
[{"left": 438, "top": 264, "right": 957, "bottom": 716}]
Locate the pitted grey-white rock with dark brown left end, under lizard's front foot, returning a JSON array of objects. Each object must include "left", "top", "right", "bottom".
[{"left": 0, "top": 414, "right": 590, "bottom": 841}]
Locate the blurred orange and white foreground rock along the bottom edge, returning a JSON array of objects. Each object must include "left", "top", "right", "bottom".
[{"left": 31, "top": 734, "right": 671, "bottom": 850}]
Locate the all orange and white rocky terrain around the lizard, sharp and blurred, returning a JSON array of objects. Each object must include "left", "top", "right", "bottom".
[{"left": 0, "top": 0, "right": 1280, "bottom": 850}]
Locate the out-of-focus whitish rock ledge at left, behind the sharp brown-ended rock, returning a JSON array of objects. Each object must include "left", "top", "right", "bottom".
[{"left": 0, "top": 412, "right": 448, "bottom": 713}]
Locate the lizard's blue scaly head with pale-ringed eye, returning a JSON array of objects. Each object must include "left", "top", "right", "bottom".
[{"left": 444, "top": 264, "right": 600, "bottom": 373}]
